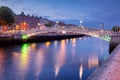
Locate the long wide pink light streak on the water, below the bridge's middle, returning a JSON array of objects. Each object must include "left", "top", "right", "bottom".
[{"left": 55, "top": 40, "right": 66, "bottom": 77}]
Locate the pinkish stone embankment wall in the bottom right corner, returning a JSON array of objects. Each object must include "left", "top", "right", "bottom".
[{"left": 87, "top": 44, "right": 120, "bottom": 80}]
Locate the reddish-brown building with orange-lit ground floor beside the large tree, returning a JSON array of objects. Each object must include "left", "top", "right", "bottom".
[{"left": 15, "top": 12, "right": 40, "bottom": 29}]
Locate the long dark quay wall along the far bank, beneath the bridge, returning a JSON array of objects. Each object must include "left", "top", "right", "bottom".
[{"left": 0, "top": 34, "right": 85, "bottom": 46}]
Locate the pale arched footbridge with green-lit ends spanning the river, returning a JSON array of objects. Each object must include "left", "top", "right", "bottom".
[{"left": 14, "top": 26, "right": 113, "bottom": 41}]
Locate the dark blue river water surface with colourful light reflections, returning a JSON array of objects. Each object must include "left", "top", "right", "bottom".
[{"left": 0, "top": 37, "right": 109, "bottom": 80}]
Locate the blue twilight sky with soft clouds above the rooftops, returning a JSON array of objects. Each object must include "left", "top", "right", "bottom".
[{"left": 0, "top": 0, "right": 120, "bottom": 29}]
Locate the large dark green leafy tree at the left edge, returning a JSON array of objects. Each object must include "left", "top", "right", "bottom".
[{"left": 0, "top": 6, "right": 15, "bottom": 26}]
